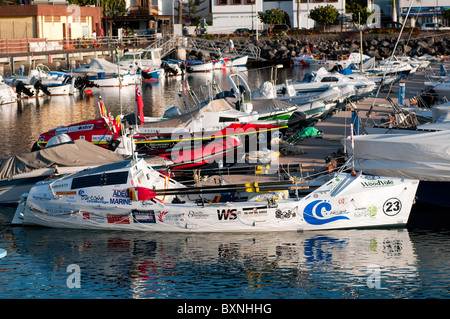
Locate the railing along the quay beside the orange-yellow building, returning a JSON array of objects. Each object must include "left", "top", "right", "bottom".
[{"left": 0, "top": 35, "right": 155, "bottom": 55}]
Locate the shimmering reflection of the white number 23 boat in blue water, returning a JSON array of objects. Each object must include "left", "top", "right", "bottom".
[{"left": 0, "top": 220, "right": 426, "bottom": 299}]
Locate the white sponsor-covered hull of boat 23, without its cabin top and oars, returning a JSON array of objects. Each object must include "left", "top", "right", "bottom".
[{"left": 13, "top": 174, "right": 418, "bottom": 232}]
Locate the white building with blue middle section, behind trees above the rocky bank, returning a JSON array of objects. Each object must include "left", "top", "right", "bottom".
[{"left": 211, "top": 0, "right": 344, "bottom": 33}]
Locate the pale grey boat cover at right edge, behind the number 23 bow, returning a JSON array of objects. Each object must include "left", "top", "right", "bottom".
[{"left": 341, "top": 131, "right": 450, "bottom": 181}]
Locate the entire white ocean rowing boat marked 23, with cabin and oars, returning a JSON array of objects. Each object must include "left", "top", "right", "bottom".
[{"left": 12, "top": 158, "right": 418, "bottom": 232}]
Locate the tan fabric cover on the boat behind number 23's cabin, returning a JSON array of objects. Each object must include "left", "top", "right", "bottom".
[{"left": 0, "top": 139, "right": 124, "bottom": 181}]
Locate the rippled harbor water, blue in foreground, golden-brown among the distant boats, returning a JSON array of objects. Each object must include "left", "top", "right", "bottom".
[{"left": 0, "top": 68, "right": 450, "bottom": 305}]
